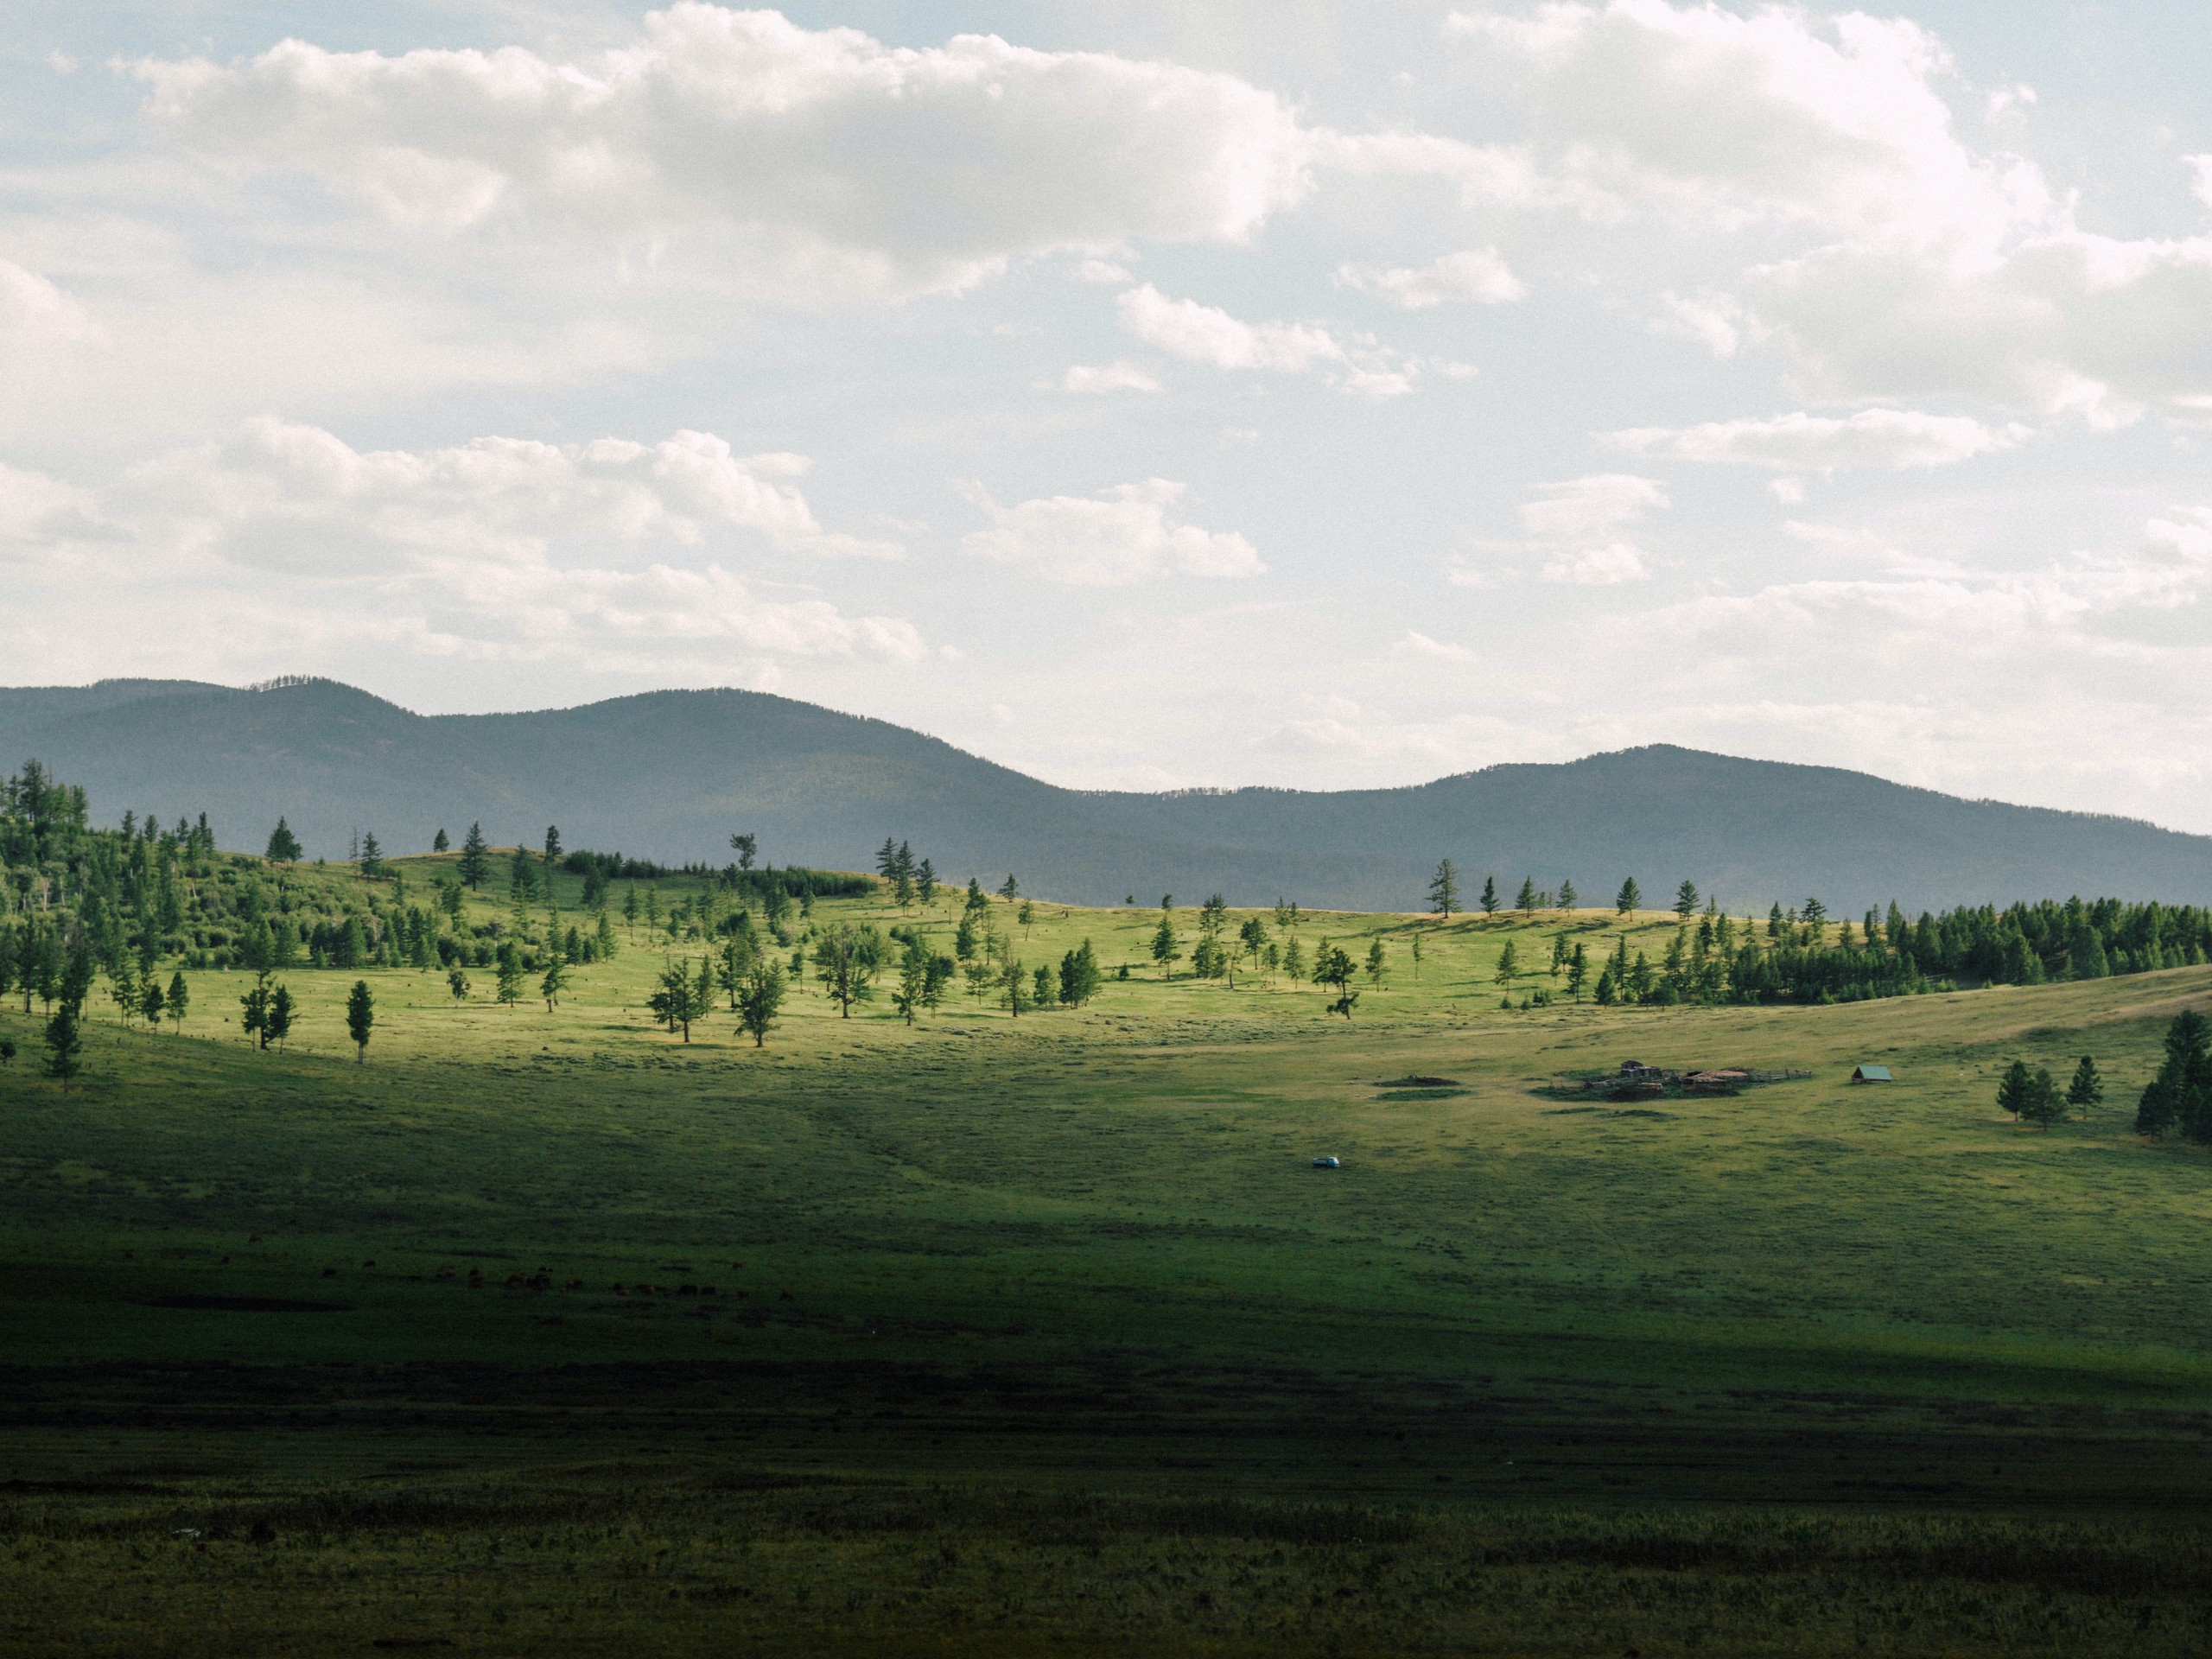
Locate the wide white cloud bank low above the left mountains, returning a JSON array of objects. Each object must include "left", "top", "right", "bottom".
[{"left": 13, "top": 420, "right": 925, "bottom": 671}]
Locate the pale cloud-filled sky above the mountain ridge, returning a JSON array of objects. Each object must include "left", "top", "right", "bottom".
[{"left": 0, "top": 0, "right": 2212, "bottom": 832}]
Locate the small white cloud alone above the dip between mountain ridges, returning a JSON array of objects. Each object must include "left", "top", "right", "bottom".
[{"left": 960, "top": 478, "right": 1268, "bottom": 588}]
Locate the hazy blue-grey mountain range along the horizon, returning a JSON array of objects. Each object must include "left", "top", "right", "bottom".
[{"left": 0, "top": 679, "right": 2212, "bottom": 913}]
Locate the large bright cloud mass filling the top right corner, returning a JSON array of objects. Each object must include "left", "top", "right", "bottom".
[{"left": 1449, "top": 0, "right": 2212, "bottom": 427}]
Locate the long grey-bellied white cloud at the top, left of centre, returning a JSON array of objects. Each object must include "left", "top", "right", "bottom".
[{"left": 133, "top": 3, "right": 1310, "bottom": 299}]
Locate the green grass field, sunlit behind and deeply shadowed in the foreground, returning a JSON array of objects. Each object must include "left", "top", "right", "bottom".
[{"left": 0, "top": 861, "right": 2212, "bottom": 1655}]
